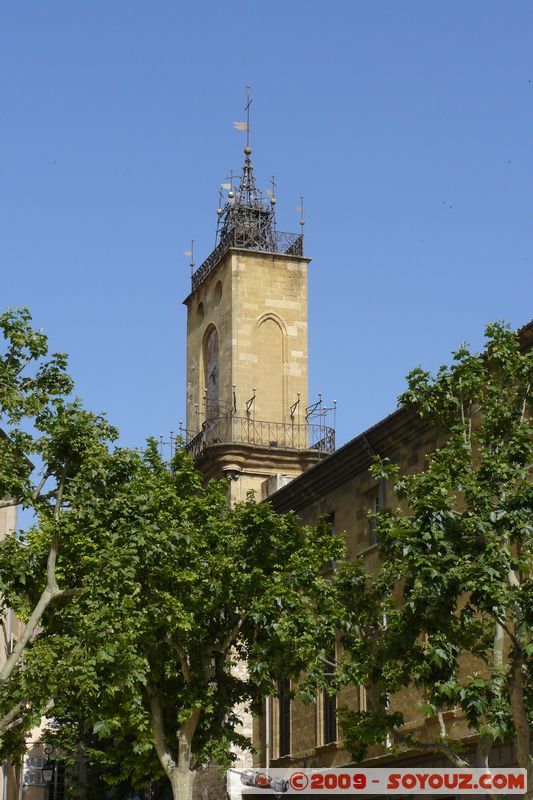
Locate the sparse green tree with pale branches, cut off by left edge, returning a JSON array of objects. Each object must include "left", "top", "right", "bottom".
[{"left": 0, "top": 309, "right": 116, "bottom": 755}]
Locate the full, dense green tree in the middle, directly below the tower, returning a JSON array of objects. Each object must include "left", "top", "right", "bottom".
[{"left": 33, "top": 442, "right": 341, "bottom": 800}]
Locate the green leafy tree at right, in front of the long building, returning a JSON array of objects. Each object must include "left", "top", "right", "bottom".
[{"left": 339, "top": 324, "right": 533, "bottom": 796}]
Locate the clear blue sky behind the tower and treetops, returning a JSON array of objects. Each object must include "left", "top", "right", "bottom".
[{"left": 0, "top": 0, "right": 533, "bottom": 445}]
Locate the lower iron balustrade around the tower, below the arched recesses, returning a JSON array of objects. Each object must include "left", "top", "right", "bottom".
[{"left": 185, "top": 417, "right": 335, "bottom": 458}]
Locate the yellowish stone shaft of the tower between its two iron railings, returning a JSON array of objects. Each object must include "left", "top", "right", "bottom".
[{"left": 186, "top": 249, "right": 309, "bottom": 430}]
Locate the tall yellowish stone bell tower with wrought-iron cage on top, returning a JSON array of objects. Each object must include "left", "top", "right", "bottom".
[{"left": 184, "top": 138, "right": 334, "bottom": 501}]
